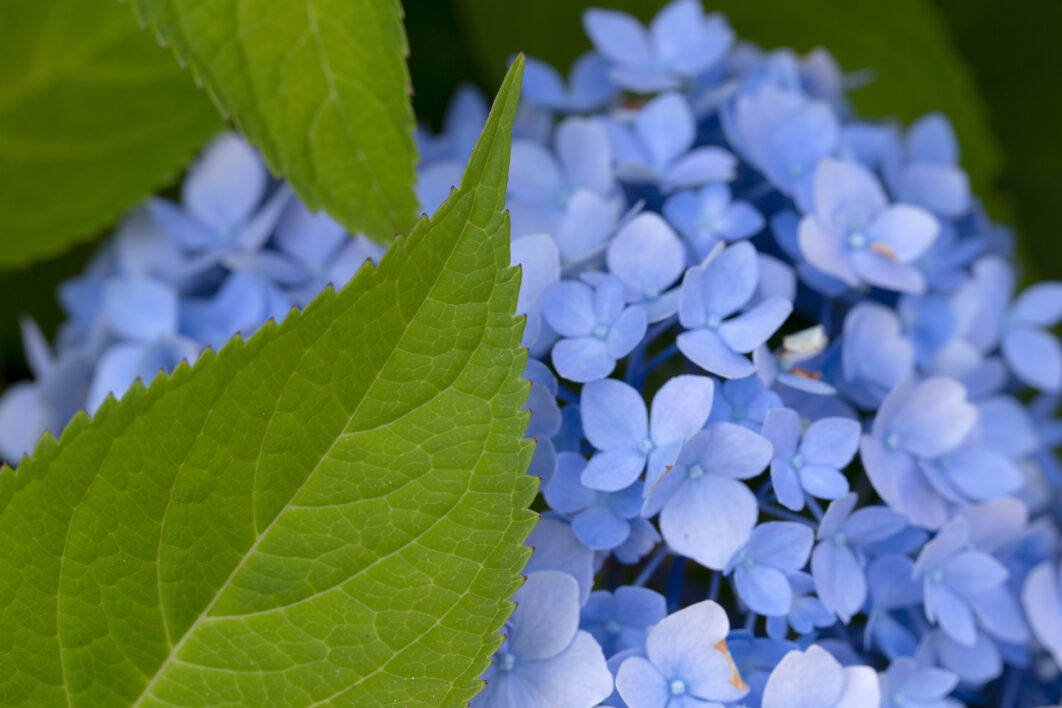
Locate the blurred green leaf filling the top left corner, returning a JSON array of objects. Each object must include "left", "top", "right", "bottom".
[{"left": 0, "top": 0, "right": 222, "bottom": 269}]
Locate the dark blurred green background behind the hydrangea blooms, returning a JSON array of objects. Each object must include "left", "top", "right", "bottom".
[{"left": 0, "top": 0, "right": 1062, "bottom": 390}]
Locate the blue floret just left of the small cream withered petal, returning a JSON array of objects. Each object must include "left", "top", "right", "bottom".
[{"left": 678, "top": 241, "right": 792, "bottom": 379}]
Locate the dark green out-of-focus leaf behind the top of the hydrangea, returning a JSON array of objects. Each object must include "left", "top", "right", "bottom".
[{"left": 457, "top": 0, "right": 998, "bottom": 195}]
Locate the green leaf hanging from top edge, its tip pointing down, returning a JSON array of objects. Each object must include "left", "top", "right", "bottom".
[{"left": 133, "top": 0, "right": 417, "bottom": 243}]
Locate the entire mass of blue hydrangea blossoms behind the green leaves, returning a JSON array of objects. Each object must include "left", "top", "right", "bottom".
[{"left": 0, "top": 0, "right": 1062, "bottom": 708}]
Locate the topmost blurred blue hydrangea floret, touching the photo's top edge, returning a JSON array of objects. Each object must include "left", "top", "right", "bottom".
[{"left": 583, "top": 0, "right": 734, "bottom": 93}]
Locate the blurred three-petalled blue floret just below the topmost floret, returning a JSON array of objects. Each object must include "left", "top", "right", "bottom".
[{"left": 605, "top": 93, "right": 737, "bottom": 190}]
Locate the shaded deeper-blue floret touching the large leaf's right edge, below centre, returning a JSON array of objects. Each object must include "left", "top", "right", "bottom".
[{"left": 543, "top": 452, "right": 641, "bottom": 551}]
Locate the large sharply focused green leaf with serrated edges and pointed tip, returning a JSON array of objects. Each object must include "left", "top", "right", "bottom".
[{"left": 0, "top": 61, "right": 535, "bottom": 707}]
